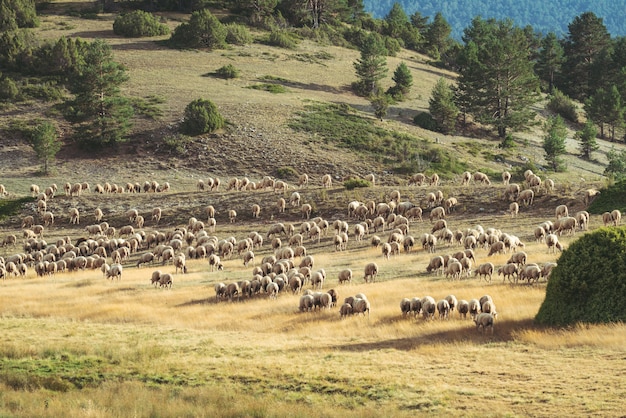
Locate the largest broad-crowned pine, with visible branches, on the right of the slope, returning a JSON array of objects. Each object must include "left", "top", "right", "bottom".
[{"left": 450, "top": 17, "right": 539, "bottom": 138}]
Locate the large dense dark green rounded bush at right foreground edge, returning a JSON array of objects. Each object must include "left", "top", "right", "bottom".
[{"left": 535, "top": 227, "right": 626, "bottom": 326}]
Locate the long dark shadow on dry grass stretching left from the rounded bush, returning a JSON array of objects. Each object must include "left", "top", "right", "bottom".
[{"left": 330, "top": 318, "right": 534, "bottom": 352}]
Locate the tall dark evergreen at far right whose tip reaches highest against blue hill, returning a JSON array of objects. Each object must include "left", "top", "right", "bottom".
[{"left": 561, "top": 12, "right": 610, "bottom": 101}]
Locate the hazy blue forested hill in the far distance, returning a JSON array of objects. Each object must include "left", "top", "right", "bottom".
[{"left": 363, "top": 0, "right": 626, "bottom": 40}]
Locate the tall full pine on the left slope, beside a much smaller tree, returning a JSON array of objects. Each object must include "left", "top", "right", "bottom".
[{"left": 70, "top": 40, "right": 133, "bottom": 145}]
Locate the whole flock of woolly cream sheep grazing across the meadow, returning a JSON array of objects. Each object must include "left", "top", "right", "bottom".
[{"left": 0, "top": 167, "right": 621, "bottom": 331}]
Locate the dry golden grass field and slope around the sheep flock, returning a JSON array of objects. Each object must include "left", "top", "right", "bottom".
[{"left": 0, "top": 2, "right": 626, "bottom": 417}]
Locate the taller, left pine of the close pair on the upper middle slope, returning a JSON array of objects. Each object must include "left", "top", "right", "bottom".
[{"left": 354, "top": 33, "right": 387, "bottom": 96}]
